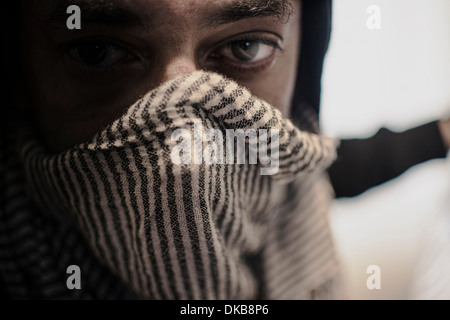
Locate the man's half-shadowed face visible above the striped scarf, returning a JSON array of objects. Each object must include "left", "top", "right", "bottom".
[{"left": 24, "top": 0, "right": 300, "bottom": 151}]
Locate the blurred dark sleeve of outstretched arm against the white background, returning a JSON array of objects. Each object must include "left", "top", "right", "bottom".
[{"left": 329, "top": 122, "right": 447, "bottom": 198}]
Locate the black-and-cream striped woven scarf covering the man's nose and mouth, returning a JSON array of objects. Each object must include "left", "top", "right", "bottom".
[{"left": 7, "top": 71, "right": 338, "bottom": 299}]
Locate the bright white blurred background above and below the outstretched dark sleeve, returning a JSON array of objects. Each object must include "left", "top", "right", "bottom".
[{"left": 321, "top": 0, "right": 450, "bottom": 299}]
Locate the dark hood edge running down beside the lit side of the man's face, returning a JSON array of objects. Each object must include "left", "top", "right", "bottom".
[{"left": 291, "top": 0, "right": 332, "bottom": 129}]
